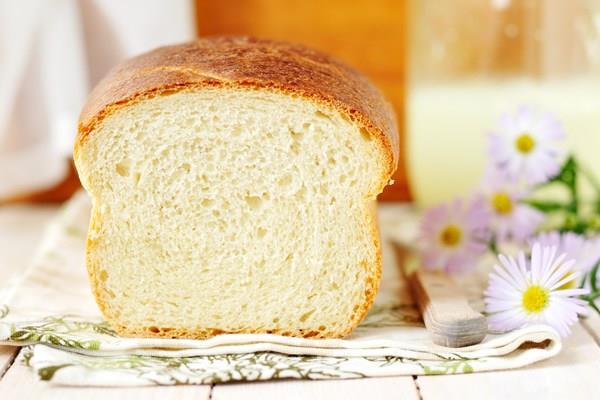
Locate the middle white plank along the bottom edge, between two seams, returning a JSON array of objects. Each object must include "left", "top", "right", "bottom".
[{"left": 211, "top": 376, "right": 419, "bottom": 400}]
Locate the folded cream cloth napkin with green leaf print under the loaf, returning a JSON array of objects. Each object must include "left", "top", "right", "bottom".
[{"left": 0, "top": 193, "right": 561, "bottom": 386}]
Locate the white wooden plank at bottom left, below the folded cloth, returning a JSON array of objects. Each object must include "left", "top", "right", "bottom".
[{"left": 0, "top": 352, "right": 211, "bottom": 400}]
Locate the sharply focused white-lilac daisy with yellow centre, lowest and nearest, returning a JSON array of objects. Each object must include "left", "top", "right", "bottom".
[{"left": 485, "top": 243, "right": 587, "bottom": 337}]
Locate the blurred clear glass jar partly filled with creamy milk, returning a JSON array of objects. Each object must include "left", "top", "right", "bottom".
[{"left": 406, "top": 0, "right": 600, "bottom": 206}]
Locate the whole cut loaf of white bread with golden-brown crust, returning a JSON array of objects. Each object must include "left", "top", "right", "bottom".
[{"left": 74, "top": 37, "right": 398, "bottom": 338}]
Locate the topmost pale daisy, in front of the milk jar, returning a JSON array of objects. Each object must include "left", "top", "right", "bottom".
[{"left": 489, "top": 107, "right": 564, "bottom": 184}]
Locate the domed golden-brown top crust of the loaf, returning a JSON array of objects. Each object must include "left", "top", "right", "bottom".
[{"left": 75, "top": 37, "right": 399, "bottom": 182}]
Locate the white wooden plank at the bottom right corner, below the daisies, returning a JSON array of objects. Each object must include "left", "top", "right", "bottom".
[{"left": 416, "top": 325, "right": 600, "bottom": 400}]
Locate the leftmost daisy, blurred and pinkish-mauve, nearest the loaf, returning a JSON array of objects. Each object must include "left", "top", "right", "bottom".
[{"left": 421, "top": 197, "right": 489, "bottom": 273}]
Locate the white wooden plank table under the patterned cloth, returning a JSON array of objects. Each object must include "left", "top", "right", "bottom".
[{"left": 0, "top": 206, "right": 600, "bottom": 400}]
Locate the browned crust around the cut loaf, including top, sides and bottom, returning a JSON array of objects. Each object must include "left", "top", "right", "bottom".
[{"left": 74, "top": 37, "right": 399, "bottom": 339}]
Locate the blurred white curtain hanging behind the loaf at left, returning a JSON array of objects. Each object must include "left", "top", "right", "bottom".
[{"left": 0, "top": 0, "right": 195, "bottom": 199}]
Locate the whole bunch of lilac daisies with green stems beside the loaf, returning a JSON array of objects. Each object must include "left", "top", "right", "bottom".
[{"left": 420, "top": 106, "right": 600, "bottom": 336}]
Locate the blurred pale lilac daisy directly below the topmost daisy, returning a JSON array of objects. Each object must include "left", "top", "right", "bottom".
[{"left": 482, "top": 171, "right": 544, "bottom": 241}]
